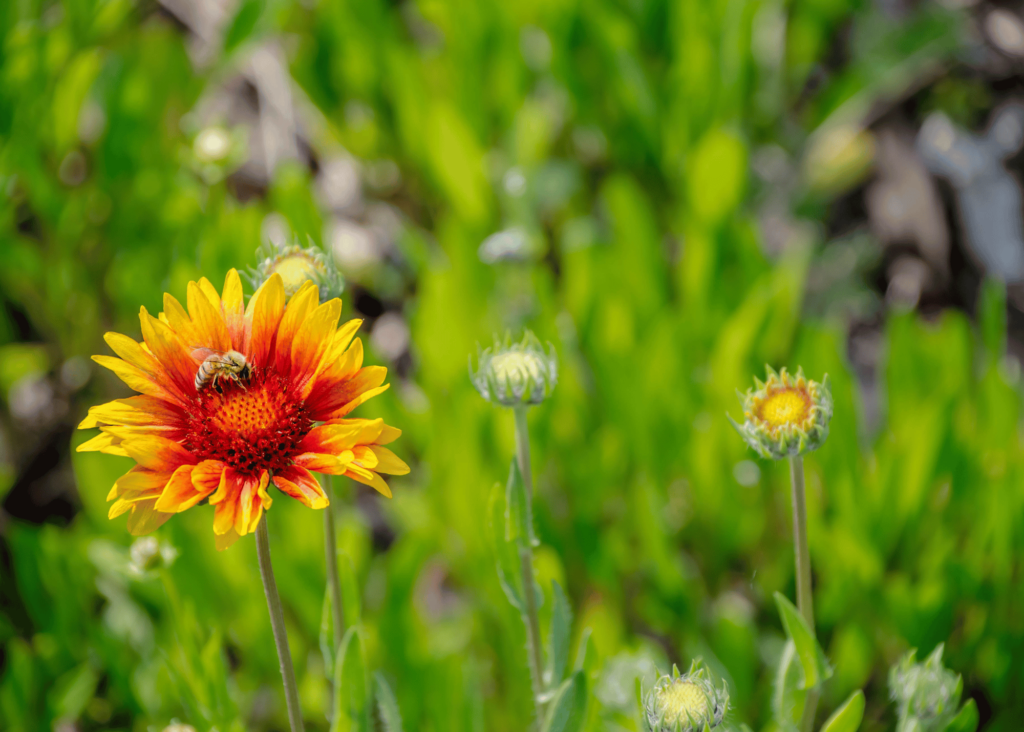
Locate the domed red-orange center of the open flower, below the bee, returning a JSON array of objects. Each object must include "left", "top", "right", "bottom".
[{"left": 183, "top": 373, "right": 313, "bottom": 476}]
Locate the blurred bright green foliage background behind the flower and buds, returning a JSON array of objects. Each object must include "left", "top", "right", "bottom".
[{"left": 0, "top": 0, "right": 1024, "bottom": 732}]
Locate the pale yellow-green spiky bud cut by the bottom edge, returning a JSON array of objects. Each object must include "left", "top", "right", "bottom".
[{"left": 643, "top": 659, "right": 729, "bottom": 732}]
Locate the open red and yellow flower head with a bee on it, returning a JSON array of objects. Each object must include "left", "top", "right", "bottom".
[{"left": 78, "top": 269, "right": 409, "bottom": 549}]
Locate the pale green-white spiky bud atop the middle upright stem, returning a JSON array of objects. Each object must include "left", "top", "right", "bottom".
[{"left": 469, "top": 331, "right": 558, "bottom": 406}]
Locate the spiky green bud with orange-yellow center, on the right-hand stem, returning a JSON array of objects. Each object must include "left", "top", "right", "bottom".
[{"left": 729, "top": 367, "right": 833, "bottom": 460}]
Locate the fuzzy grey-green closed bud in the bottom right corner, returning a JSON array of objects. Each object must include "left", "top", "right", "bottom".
[{"left": 889, "top": 643, "right": 964, "bottom": 732}]
